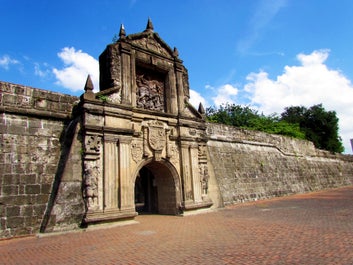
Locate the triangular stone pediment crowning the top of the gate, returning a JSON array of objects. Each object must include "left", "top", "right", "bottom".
[{"left": 126, "top": 31, "right": 174, "bottom": 58}]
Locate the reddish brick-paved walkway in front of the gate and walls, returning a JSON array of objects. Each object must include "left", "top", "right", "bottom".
[{"left": 0, "top": 187, "right": 353, "bottom": 265}]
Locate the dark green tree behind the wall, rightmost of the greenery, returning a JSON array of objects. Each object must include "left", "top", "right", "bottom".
[{"left": 281, "top": 104, "right": 344, "bottom": 153}]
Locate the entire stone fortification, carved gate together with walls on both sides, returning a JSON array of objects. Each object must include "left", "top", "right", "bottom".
[{"left": 0, "top": 20, "right": 353, "bottom": 238}]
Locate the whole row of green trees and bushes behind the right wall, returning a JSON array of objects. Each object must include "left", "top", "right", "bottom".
[{"left": 206, "top": 104, "right": 344, "bottom": 153}]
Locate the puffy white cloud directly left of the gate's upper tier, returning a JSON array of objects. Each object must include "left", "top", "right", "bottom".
[{"left": 53, "top": 47, "right": 99, "bottom": 92}]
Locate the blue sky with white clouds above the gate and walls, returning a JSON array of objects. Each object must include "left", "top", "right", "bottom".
[{"left": 0, "top": 0, "right": 353, "bottom": 153}]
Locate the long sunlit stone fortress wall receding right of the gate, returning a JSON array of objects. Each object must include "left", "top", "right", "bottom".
[{"left": 207, "top": 124, "right": 353, "bottom": 205}]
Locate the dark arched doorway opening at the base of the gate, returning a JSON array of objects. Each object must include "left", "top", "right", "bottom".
[{"left": 135, "top": 161, "right": 180, "bottom": 215}]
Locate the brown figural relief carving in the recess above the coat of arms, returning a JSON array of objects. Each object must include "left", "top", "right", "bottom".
[{"left": 136, "top": 74, "right": 164, "bottom": 112}]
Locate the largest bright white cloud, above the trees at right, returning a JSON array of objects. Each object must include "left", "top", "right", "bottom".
[{"left": 244, "top": 50, "right": 353, "bottom": 153}]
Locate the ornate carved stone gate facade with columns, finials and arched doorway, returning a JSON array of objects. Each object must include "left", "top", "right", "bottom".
[{"left": 81, "top": 20, "right": 212, "bottom": 223}]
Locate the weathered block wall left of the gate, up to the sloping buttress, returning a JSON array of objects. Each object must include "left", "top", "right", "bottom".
[{"left": 0, "top": 82, "right": 82, "bottom": 238}]
